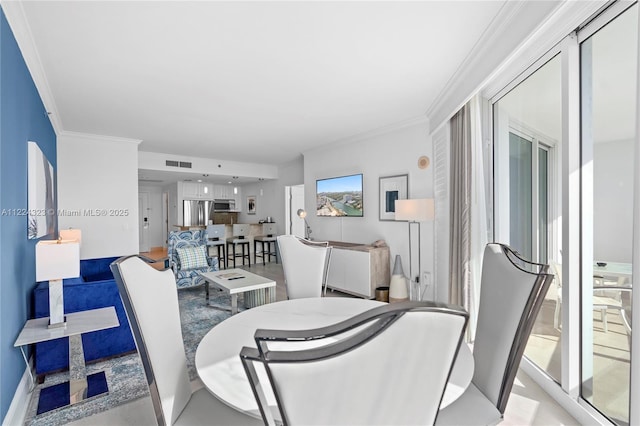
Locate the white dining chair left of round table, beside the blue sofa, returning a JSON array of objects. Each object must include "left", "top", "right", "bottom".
[{"left": 111, "top": 256, "right": 260, "bottom": 426}]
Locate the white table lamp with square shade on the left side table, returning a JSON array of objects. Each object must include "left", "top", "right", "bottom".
[{"left": 36, "top": 239, "right": 80, "bottom": 328}]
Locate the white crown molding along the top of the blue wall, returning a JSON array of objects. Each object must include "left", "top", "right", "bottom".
[{"left": 0, "top": 0, "right": 63, "bottom": 135}]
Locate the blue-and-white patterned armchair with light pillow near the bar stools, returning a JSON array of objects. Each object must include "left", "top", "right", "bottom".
[{"left": 167, "top": 229, "right": 218, "bottom": 288}]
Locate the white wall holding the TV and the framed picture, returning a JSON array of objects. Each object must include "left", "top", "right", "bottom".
[{"left": 304, "top": 119, "right": 434, "bottom": 288}]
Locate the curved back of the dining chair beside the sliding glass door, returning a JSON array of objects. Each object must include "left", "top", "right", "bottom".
[{"left": 473, "top": 243, "right": 553, "bottom": 413}]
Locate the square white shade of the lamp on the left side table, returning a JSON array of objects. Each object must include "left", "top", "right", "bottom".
[{"left": 36, "top": 240, "right": 80, "bottom": 281}]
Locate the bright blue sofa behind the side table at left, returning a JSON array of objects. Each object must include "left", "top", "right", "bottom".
[{"left": 34, "top": 257, "right": 136, "bottom": 375}]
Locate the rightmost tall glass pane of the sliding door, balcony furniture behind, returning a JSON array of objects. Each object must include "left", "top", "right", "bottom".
[{"left": 580, "top": 5, "right": 638, "bottom": 424}]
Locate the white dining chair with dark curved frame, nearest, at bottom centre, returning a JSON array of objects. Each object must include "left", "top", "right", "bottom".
[{"left": 240, "top": 302, "right": 468, "bottom": 425}]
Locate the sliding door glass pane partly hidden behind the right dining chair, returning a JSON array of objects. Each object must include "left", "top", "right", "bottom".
[{"left": 493, "top": 56, "right": 562, "bottom": 381}]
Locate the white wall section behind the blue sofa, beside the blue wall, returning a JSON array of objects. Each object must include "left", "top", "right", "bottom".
[{"left": 57, "top": 133, "right": 139, "bottom": 259}]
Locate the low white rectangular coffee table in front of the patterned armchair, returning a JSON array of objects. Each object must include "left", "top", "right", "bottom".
[{"left": 199, "top": 268, "right": 276, "bottom": 315}]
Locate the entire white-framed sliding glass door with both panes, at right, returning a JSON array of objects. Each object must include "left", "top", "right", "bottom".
[{"left": 491, "top": 2, "right": 640, "bottom": 425}]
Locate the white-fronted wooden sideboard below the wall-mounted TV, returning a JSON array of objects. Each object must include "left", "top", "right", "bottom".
[{"left": 327, "top": 241, "right": 390, "bottom": 299}]
